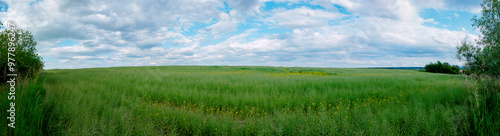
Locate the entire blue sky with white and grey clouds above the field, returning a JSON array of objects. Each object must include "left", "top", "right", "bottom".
[{"left": 0, "top": 0, "right": 481, "bottom": 69}]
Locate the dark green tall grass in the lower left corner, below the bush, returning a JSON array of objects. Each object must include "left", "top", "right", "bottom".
[{"left": 0, "top": 73, "right": 60, "bottom": 135}]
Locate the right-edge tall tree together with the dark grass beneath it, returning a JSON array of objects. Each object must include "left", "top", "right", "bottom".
[{"left": 457, "top": 0, "right": 500, "bottom": 135}]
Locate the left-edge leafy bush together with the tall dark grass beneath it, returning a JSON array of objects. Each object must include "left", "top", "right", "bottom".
[{"left": 0, "top": 22, "right": 52, "bottom": 135}]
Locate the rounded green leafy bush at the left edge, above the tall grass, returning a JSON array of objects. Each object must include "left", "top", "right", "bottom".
[{"left": 0, "top": 22, "right": 43, "bottom": 82}]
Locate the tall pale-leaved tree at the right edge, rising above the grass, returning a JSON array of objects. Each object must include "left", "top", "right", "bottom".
[{"left": 457, "top": 0, "right": 500, "bottom": 78}]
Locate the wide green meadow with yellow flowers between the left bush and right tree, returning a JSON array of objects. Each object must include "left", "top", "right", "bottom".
[{"left": 2, "top": 66, "right": 471, "bottom": 135}]
